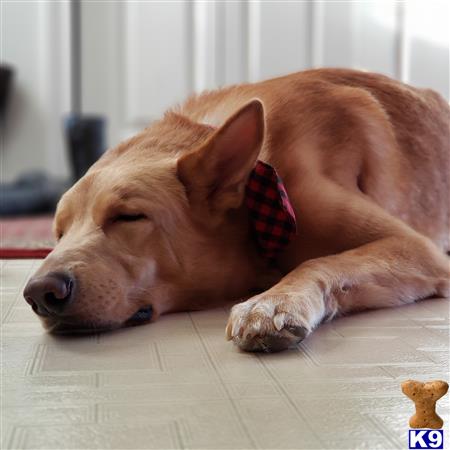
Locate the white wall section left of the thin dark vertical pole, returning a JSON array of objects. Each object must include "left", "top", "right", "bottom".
[{"left": 0, "top": 0, "right": 70, "bottom": 182}]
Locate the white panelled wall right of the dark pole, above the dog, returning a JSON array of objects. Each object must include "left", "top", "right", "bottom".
[{"left": 83, "top": 0, "right": 450, "bottom": 149}]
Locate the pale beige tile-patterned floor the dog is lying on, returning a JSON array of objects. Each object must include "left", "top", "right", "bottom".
[{"left": 1, "top": 261, "right": 450, "bottom": 449}]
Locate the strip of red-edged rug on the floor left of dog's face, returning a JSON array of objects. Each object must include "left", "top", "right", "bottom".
[{"left": 0, "top": 216, "right": 55, "bottom": 259}]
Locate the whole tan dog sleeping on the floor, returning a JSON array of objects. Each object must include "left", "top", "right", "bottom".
[{"left": 24, "top": 69, "right": 450, "bottom": 352}]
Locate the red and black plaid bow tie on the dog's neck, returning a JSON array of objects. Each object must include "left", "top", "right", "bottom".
[{"left": 245, "top": 161, "right": 297, "bottom": 260}]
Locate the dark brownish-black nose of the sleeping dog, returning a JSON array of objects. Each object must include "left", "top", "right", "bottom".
[{"left": 23, "top": 272, "right": 75, "bottom": 316}]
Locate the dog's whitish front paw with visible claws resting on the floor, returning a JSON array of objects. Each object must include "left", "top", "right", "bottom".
[{"left": 226, "top": 294, "right": 312, "bottom": 352}]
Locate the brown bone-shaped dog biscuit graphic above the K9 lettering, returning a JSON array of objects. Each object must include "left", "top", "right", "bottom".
[{"left": 402, "top": 380, "right": 448, "bottom": 430}]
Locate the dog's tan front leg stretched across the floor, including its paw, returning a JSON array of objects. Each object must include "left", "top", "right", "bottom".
[{"left": 226, "top": 182, "right": 450, "bottom": 351}]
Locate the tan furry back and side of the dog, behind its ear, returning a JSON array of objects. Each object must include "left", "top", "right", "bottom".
[{"left": 179, "top": 69, "right": 450, "bottom": 251}]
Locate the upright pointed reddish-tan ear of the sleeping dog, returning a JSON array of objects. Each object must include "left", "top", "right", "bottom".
[{"left": 177, "top": 100, "right": 264, "bottom": 218}]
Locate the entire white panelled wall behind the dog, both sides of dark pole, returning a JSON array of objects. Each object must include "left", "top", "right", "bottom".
[{"left": 1, "top": 0, "right": 450, "bottom": 183}]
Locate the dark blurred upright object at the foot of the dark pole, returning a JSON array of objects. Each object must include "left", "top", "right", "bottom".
[{"left": 65, "top": 114, "right": 106, "bottom": 181}]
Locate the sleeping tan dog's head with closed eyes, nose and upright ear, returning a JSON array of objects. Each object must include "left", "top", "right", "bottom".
[{"left": 24, "top": 101, "right": 278, "bottom": 331}]
